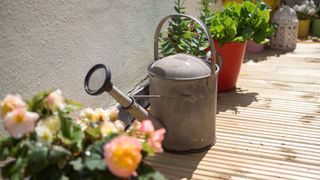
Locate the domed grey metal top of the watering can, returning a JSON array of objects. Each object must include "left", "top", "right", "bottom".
[{"left": 148, "top": 54, "right": 211, "bottom": 80}]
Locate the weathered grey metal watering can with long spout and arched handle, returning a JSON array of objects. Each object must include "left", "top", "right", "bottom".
[{"left": 85, "top": 14, "right": 221, "bottom": 153}]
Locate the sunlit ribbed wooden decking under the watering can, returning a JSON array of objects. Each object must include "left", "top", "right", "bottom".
[{"left": 148, "top": 44, "right": 320, "bottom": 180}]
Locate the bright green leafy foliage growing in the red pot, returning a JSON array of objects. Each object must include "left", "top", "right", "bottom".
[{"left": 209, "top": 1, "right": 276, "bottom": 46}]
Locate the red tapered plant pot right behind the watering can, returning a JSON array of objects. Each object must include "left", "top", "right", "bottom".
[{"left": 207, "top": 41, "right": 247, "bottom": 92}]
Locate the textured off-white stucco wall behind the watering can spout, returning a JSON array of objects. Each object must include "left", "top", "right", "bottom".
[{"left": 0, "top": 0, "right": 173, "bottom": 107}]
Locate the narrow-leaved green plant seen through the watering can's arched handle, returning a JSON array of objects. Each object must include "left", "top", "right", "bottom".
[{"left": 160, "top": 0, "right": 213, "bottom": 57}]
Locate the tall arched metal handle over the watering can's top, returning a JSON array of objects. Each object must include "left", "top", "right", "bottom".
[{"left": 154, "top": 14, "right": 216, "bottom": 74}]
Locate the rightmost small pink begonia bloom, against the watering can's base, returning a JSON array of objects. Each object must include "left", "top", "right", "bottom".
[{"left": 148, "top": 128, "right": 166, "bottom": 153}]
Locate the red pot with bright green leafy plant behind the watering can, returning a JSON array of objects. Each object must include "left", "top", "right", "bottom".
[{"left": 208, "top": 1, "right": 275, "bottom": 92}]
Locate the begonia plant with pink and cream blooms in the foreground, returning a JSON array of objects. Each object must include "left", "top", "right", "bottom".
[{"left": 0, "top": 90, "right": 165, "bottom": 180}]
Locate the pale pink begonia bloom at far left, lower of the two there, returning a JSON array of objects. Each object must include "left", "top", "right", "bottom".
[{"left": 4, "top": 108, "right": 39, "bottom": 138}]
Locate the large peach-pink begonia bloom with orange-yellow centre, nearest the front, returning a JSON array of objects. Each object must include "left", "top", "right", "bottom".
[{"left": 104, "top": 135, "right": 142, "bottom": 178}]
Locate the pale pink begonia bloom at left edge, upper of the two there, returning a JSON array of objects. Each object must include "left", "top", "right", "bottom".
[{"left": 0, "top": 95, "right": 26, "bottom": 118}]
